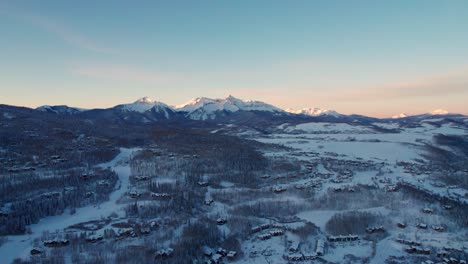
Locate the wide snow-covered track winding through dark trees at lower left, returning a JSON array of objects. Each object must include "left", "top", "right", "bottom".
[{"left": 0, "top": 148, "right": 137, "bottom": 263}]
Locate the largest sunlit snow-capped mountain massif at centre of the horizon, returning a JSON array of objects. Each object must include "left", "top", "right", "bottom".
[{"left": 175, "top": 96, "right": 284, "bottom": 120}]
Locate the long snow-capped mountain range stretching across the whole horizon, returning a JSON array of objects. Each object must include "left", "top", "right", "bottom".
[{"left": 0, "top": 95, "right": 467, "bottom": 125}]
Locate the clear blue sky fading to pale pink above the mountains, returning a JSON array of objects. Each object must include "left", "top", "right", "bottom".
[{"left": 0, "top": 0, "right": 468, "bottom": 117}]
